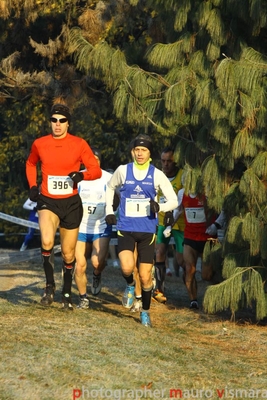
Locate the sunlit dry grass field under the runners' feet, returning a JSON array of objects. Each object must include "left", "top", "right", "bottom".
[{"left": 0, "top": 253, "right": 267, "bottom": 400}]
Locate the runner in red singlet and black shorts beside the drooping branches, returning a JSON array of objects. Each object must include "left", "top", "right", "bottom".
[{"left": 175, "top": 189, "right": 215, "bottom": 309}]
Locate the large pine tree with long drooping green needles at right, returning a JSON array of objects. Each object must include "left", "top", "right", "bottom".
[{"left": 69, "top": 0, "right": 267, "bottom": 319}]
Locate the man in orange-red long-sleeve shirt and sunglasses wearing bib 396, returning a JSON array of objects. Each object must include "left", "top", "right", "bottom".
[{"left": 26, "top": 104, "right": 102, "bottom": 310}]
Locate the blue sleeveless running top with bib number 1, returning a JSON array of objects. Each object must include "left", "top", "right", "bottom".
[{"left": 117, "top": 163, "right": 158, "bottom": 233}]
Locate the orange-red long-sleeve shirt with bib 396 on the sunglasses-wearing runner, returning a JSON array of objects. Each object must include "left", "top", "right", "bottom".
[{"left": 26, "top": 133, "right": 102, "bottom": 199}]
